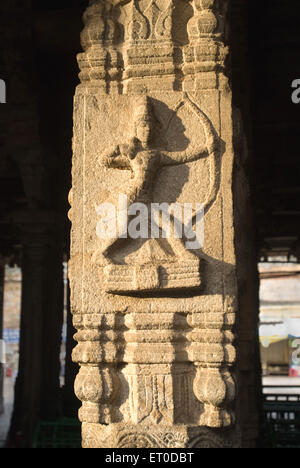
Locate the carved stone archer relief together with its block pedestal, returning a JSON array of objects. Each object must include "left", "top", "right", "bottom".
[{"left": 93, "top": 95, "right": 220, "bottom": 293}]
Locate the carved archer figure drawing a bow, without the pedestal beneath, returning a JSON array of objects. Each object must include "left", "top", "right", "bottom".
[{"left": 94, "top": 95, "right": 218, "bottom": 265}]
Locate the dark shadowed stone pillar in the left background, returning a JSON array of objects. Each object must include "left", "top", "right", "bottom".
[{"left": 10, "top": 211, "right": 63, "bottom": 447}]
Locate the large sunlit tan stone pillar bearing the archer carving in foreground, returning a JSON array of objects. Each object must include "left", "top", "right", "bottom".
[{"left": 70, "top": 0, "right": 241, "bottom": 448}]
